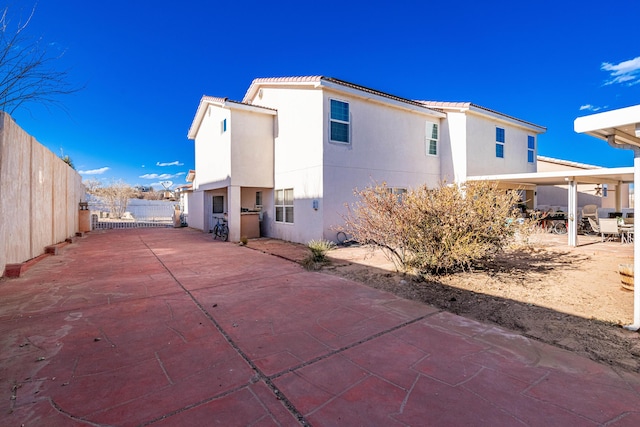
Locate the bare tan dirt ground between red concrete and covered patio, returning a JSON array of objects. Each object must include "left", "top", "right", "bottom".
[{"left": 322, "top": 234, "right": 640, "bottom": 372}]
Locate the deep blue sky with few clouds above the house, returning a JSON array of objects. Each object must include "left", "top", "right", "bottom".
[{"left": 8, "top": 0, "right": 640, "bottom": 189}]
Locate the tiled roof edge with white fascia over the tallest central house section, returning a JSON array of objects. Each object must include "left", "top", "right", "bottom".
[{"left": 242, "top": 76, "right": 445, "bottom": 118}]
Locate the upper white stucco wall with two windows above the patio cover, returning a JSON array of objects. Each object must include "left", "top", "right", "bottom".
[{"left": 467, "top": 113, "right": 538, "bottom": 176}]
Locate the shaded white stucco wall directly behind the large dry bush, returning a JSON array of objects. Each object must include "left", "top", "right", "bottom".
[{"left": 321, "top": 90, "right": 443, "bottom": 240}]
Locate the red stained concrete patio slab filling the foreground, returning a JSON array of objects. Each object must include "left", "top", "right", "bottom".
[{"left": 0, "top": 229, "right": 640, "bottom": 426}]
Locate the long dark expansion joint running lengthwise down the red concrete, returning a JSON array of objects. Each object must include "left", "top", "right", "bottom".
[{"left": 140, "top": 236, "right": 311, "bottom": 426}]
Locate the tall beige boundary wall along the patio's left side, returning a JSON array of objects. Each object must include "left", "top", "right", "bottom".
[{"left": 0, "top": 112, "right": 85, "bottom": 273}]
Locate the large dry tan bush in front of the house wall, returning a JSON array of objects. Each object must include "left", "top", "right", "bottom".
[{"left": 344, "top": 182, "right": 527, "bottom": 274}]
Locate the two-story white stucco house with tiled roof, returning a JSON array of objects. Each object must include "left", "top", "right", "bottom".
[{"left": 187, "top": 76, "right": 546, "bottom": 243}]
